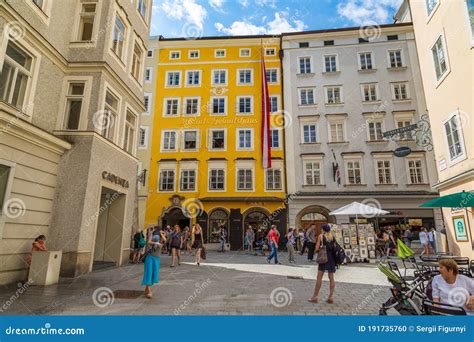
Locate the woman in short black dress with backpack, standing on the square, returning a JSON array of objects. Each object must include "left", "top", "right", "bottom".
[{"left": 308, "top": 224, "right": 337, "bottom": 304}]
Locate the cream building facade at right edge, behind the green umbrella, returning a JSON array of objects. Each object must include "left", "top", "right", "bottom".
[{"left": 396, "top": 0, "right": 474, "bottom": 258}]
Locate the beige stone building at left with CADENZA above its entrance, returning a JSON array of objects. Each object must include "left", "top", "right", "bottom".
[{"left": 0, "top": 0, "right": 152, "bottom": 284}]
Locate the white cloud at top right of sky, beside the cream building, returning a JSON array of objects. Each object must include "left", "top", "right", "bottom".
[{"left": 337, "top": 0, "right": 402, "bottom": 25}]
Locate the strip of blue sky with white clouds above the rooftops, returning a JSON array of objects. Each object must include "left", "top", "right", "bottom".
[{"left": 151, "top": 0, "right": 401, "bottom": 37}]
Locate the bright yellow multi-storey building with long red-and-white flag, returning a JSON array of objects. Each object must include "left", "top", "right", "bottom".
[{"left": 145, "top": 36, "right": 287, "bottom": 250}]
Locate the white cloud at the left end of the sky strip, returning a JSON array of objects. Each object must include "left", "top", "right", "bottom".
[{"left": 161, "top": 0, "right": 207, "bottom": 30}]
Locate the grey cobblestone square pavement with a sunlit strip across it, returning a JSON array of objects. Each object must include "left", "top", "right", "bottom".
[{"left": 0, "top": 252, "right": 390, "bottom": 315}]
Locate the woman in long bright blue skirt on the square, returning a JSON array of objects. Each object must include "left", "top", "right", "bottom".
[{"left": 142, "top": 230, "right": 166, "bottom": 299}]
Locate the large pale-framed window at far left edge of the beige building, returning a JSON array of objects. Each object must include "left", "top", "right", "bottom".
[{"left": 0, "top": 41, "right": 33, "bottom": 110}]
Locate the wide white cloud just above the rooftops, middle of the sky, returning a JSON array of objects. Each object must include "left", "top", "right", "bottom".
[{"left": 214, "top": 12, "right": 306, "bottom": 36}]
